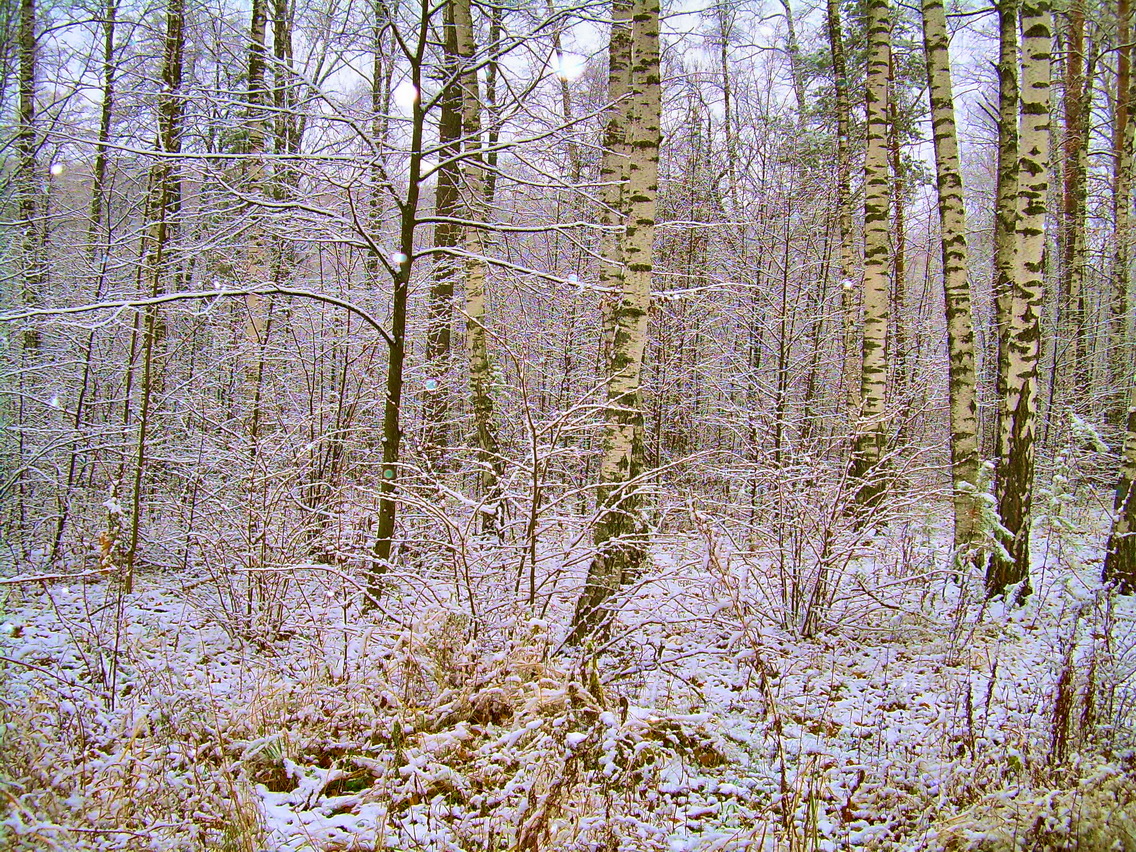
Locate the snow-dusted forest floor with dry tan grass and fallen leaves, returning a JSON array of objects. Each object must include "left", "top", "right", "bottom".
[{"left": 0, "top": 504, "right": 1136, "bottom": 852}]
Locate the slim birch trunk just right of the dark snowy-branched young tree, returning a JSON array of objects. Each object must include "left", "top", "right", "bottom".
[{"left": 451, "top": 0, "right": 504, "bottom": 533}]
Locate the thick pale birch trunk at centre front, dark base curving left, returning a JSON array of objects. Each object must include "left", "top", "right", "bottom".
[{"left": 571, "top": 0, "right": 661, "bottom": 641}]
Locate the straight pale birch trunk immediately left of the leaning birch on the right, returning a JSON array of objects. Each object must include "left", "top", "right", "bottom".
[{"left": 851, "top": 0, "right": 892, "bottom": 507}]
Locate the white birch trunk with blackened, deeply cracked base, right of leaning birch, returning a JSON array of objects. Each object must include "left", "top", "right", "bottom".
[{"left": 986, "top": 0, "right": 1053, "bottom": 600}]
